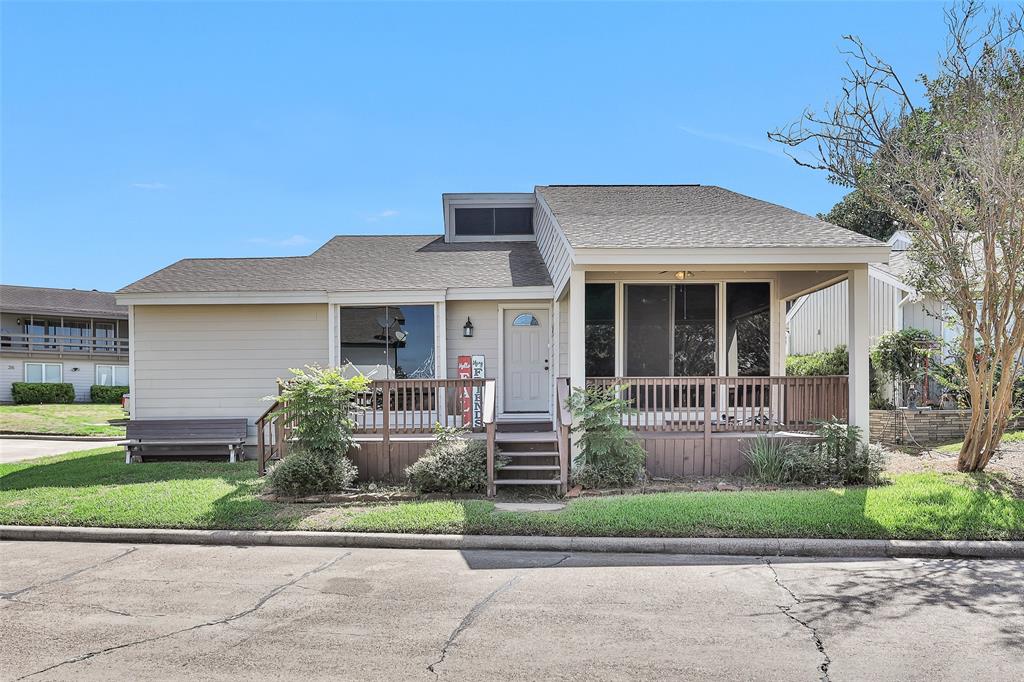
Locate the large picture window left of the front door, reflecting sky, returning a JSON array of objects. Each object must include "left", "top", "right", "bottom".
[{"left": 339, "top": 305, "right": 435, "bottom": 379}]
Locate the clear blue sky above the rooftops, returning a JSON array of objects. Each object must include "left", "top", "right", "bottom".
[{"left": 0, "top": 2, "right": 944, "bottom": 290}]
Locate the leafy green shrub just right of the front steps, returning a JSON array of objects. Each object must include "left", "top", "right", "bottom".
[{"left": 568, "top": 386, "right": 647, "bottom": 487}]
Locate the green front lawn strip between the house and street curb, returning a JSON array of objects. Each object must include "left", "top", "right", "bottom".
[{"left": 0, "top": 449, "right": 1024, "bottom": 540}]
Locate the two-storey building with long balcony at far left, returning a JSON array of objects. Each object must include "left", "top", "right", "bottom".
[{"left": 0, "top": 285, "right": 129, "bottom": 402}]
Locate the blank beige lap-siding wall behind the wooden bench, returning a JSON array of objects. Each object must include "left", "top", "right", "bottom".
[{"left": 132, "top": 304, "right": 328, "bottom": 436}]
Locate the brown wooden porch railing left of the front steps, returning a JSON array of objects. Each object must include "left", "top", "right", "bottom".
[{"left": 256, "top": 379, "right": 496, "bottom": 476}]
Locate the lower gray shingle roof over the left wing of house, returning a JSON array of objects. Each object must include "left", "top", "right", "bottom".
[{"left": 120, "top": 236, "right": 551, "bottom": 294}]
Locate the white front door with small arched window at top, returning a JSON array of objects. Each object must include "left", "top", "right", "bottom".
[{"left": 503, "top": 308, "right": 551, "bottom": 413}]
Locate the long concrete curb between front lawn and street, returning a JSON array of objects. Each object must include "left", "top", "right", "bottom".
[{"left": 0, "top": 525, "right": 1024, "bottom": 559}]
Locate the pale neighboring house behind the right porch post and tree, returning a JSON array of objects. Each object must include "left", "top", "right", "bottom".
[{"left": 785, "top": 230, "right": 959, "bottom": 400}]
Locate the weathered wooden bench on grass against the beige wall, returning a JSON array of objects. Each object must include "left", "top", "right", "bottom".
[{"left": 118, "top": 417, "right": 248, "bottom": 464}]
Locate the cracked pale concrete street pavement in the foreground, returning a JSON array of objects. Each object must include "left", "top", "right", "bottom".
[{"left": 0, "top": 542, "right": 1024, "bottom": 682}]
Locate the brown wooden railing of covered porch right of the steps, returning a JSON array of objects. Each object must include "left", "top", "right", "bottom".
[{"left": 587, "top": 376, "right": 849, "bottom": 434}]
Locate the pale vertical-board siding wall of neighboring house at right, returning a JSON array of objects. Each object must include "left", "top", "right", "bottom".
[{"left": 788, "top": 278, "right": 904, "bottom": 355}]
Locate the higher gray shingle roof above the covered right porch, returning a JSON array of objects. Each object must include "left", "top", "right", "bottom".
[{"left": 537, "top": 184, "right": 884, "bottom": 249}]
